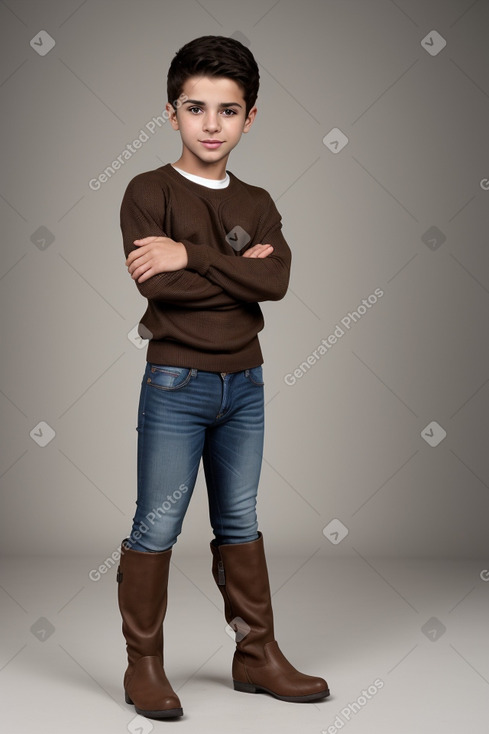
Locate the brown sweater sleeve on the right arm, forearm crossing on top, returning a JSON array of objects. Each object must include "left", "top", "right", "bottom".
[{"left": 183, "top": 194, "right": 291, "bottom": 303}]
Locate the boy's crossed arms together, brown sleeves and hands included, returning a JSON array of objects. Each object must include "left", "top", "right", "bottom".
[{"left": 121, "top": 177, "right": 291, "bottom": 308}]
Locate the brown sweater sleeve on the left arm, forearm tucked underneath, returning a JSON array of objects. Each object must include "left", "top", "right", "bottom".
[{"left": 120, "top": 173, "right": 236, "bottom": 309}]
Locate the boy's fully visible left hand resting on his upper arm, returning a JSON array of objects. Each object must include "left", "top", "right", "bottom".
[{"left": 126, "top": 237, "right": 188, "bottom": 283}]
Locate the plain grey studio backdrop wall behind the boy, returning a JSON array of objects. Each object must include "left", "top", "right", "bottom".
[{"left": 0, "top": 0, "right": 489, "bottom": 558}]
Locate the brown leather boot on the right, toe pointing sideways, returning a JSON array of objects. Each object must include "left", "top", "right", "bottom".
[{"left": 211, "top": 533, "right": 329, "bottom": 703}]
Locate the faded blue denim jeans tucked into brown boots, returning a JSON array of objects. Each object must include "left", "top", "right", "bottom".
[{"left": 129, "top": 363, "right": 264, "bottom": 551}]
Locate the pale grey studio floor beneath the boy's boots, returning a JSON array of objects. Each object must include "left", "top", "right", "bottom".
[{"left": 0, "top": 551, "right": 489, "bottom": 734}]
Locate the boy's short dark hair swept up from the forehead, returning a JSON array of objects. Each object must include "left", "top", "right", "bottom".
[{"left": 167, "top": 36, "right": 260, "bottom": 114}]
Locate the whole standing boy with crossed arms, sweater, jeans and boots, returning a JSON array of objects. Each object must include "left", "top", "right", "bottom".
[{"left": 117, "top": 36, "right": 329, "bottom": 719}]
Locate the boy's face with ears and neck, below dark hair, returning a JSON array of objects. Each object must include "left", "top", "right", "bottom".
[{"left": 166, "top": 76, "right": 256, "bottom": 178}]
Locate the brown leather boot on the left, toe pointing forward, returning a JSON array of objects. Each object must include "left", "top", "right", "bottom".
[{"left": 117, "top": 541, "right": 183, "bottom": 719}]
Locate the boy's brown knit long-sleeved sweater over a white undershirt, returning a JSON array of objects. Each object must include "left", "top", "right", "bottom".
[{"left": 121, "top": 164, "right": 291, "bottom": 372}]
